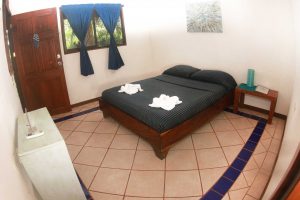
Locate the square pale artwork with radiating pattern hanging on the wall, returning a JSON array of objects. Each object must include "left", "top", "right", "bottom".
[{"left": 186, "top": 0, "right": 223, "bottom": 33}]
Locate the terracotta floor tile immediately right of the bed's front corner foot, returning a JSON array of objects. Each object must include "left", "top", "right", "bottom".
[{"left": 166, "top": 150, "right": 198, "bottom": 170}]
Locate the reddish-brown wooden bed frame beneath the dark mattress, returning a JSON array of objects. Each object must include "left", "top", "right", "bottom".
[{"left": 99, "top": 91, "right": 233, "bottom": 159}]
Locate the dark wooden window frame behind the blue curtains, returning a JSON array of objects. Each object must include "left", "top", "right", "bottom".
[{"left": 60, "top": 7, "right": 127, "bottom": 54}]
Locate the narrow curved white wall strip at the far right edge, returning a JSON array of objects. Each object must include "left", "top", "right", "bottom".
[{"left": 263, "top": 0, "right": 300, "bottom": 199}]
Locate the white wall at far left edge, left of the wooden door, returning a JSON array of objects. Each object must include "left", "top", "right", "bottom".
[{"left": 0, "top": 1, "right": 35, "bottom": 200}]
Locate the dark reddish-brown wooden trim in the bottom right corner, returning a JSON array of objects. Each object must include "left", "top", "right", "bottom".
[{"left": 270, "top": 147, "right": 300, "bottom": 200}]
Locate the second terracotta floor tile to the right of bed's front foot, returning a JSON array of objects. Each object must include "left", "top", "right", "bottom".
[{"left": 196, "top": 148, "right": 228, "bottom": 169}]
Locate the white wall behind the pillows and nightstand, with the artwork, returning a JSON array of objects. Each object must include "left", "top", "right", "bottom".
[{"left": 150, "top": 0, "right": 294, "bottom": 114}]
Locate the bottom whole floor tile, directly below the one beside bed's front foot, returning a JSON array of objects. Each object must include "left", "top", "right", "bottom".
[{"left": 165, "top": 170, "right": 202, "bottom": 197}]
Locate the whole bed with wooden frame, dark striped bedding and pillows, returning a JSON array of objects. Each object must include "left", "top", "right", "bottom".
[{"left": 99, "top": 65, "right": 236, "bottom": 159}]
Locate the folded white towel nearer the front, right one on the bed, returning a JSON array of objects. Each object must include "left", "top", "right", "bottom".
[{"left": 149, "top": 94, "right": 182, "bottom": 111}]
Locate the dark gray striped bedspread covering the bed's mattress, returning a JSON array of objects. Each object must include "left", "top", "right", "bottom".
[{"left": 102, "top": 75, "right": 226, "bottom": 132}]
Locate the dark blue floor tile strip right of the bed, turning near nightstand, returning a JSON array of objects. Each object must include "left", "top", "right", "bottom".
[{"left": 201, "top": 108, "right": 267, "bottom": 200}]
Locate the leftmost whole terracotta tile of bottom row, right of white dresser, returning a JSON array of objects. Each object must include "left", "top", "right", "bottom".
[{"left": 90, "top": 168, "right": 130, "bottom": 195}]
